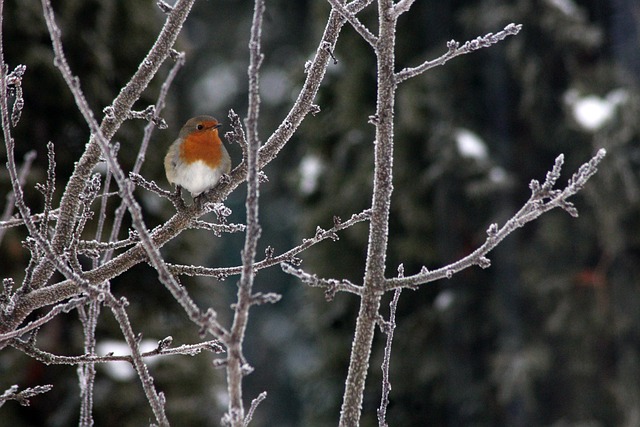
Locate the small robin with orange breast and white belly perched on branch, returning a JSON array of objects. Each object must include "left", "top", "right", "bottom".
[{"left": 164, "top": 116, "right": 231, "bottom": 197}]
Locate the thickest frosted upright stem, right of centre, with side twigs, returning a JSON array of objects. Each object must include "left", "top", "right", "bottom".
[{"left": 340, "top": 0, "right": 396, "bottom": 426}]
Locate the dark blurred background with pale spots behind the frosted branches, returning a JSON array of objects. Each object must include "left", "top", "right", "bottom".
[{"left": 0, "top": 0, "right": 640, "bottom": 427}]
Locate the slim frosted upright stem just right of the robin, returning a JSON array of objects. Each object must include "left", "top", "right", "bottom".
[{"left": 226, "top": 0, "right": 264, "bottom": 426}]
